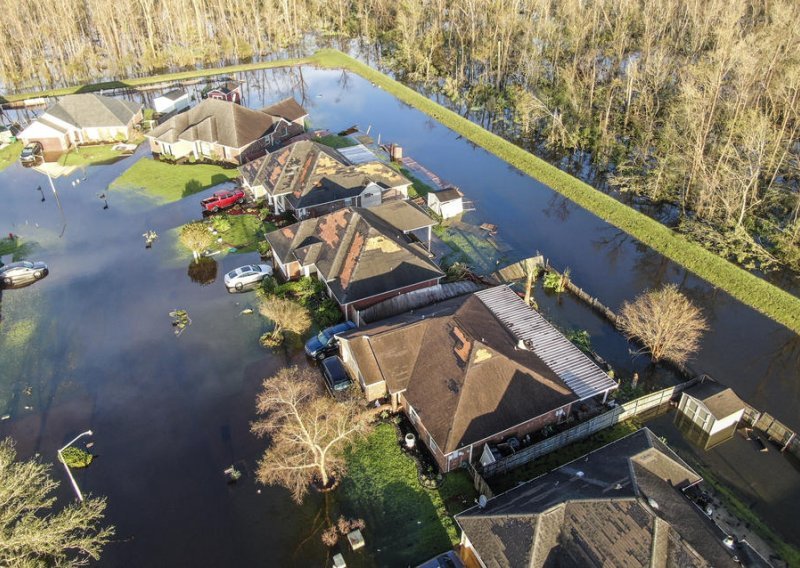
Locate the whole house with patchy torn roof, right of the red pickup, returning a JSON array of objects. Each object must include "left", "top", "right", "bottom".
[{"left": 240, "top": 140, "right": 411, "bottom": 219}]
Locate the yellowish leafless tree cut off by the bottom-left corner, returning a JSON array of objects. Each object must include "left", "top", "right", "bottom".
[{"left": 0, "top": 438, "right": 114, "bottom": 566}]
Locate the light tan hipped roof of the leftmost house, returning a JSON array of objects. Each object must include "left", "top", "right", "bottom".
[{"left": 44, "top": 93, "right": 142, "bottom": 128}]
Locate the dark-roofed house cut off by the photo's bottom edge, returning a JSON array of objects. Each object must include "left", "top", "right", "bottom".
[{"left": 455, "top": 428, "right": 753, "bottom": 568}]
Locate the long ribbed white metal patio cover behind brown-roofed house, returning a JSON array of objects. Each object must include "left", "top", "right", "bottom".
[{"left": 475, "top": 286, "right": 617, "bottom": 399}]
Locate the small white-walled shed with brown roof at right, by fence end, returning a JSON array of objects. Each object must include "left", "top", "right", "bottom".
[{"left": 678, "top": 379, "right": 745, "bottom": 444}]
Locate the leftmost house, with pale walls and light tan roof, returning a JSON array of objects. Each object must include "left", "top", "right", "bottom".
[{"left": 18, "top": 93, "right": 142, "bottom": 156}]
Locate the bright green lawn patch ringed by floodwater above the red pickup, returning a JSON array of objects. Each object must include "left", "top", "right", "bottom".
[{"left": 110, "top": 158, "right": 239, "bottom": 202}]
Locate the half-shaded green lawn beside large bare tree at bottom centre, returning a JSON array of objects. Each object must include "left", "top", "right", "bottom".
[{"left": 338, "top": 424, "right": 476, "bottom": 566}]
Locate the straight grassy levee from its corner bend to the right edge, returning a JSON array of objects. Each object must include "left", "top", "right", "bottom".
[{"left": 312, "top": 49, "right": 800, "bottom": 333}]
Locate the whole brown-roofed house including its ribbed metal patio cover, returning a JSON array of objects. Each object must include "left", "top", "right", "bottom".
[{"left": 339, "top": 286, "right": 617, "bottom": 471}]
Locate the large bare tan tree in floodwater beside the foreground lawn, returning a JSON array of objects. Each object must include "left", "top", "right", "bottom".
[{"left": 251, "top": 367, "right": 370, "bottom": 503}]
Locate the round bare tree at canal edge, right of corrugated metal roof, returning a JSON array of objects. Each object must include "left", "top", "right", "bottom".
[{"left": 617, "top": 284, "right": 708, "bottom": 366}]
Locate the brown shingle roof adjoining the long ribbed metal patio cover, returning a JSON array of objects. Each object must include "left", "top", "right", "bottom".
[{"left": 334, "top": 293, "right": 596, "bottom": 453}]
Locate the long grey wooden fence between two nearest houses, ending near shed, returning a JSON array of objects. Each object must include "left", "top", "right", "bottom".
[{"left": 478, "top": 378, "right": 700, "bottom": 478}]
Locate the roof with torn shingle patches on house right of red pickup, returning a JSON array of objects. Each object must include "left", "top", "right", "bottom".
[{"left": 247, "top": 140, "right": 411, "bottom": 209}]
